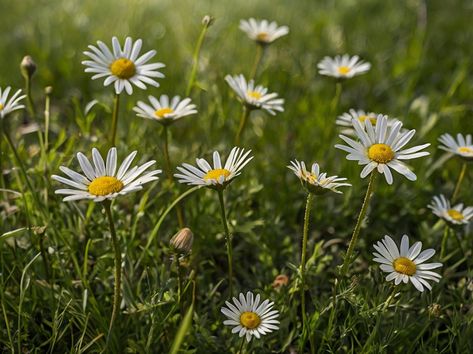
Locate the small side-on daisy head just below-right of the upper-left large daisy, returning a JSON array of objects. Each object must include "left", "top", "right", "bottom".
[{"left": 133, "top": 95, "right": 197, "bottom": 124}]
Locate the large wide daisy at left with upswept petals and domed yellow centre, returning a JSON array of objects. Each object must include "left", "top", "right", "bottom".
[{"left": 52, "top": 147, "right": 161, "bottom": 202}]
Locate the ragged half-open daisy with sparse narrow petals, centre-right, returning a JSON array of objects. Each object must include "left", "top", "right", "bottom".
[{"left": 287, "top": 160, "right": 351, "bottom": 194}]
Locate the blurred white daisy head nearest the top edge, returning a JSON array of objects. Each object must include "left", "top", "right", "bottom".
[{"left": 240, "top": 18, "right": 289, "bottom": 45}]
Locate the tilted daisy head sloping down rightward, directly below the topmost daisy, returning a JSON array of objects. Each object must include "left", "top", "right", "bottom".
[{"left": 225, "top": 74, "right": 284, "bottom": 115}]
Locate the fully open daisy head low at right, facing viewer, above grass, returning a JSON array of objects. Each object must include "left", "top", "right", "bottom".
[{"left": 373, "top": 235, "right": 442, "bottom": 291}]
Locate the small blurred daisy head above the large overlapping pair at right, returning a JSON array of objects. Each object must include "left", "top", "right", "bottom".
[{"left": 317, "top": 54, "right": 371, "bottom": 79}]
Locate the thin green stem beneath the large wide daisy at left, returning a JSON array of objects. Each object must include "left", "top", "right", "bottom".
[{"left": 104, "top": 201, "right": 122, "bottom": 341}]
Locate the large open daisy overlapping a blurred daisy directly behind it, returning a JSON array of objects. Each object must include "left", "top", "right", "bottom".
[{"left": 335, "top": 116, "right": 430, "bottom": 184}]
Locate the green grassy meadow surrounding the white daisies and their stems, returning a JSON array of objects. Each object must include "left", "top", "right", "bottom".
[{"left": 0, "top": 0, "right": 473, "bottom": 353}]
